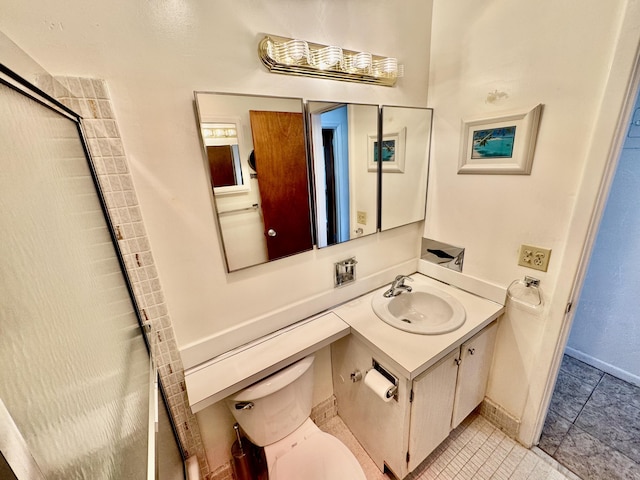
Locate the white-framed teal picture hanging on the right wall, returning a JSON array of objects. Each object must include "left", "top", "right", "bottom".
[{"left": 458, "top": 104, "right": 542, "bottom": 175}]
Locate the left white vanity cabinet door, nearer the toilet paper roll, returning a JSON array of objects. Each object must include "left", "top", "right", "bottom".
[{"left": 408, "top": 349, "right": 459, "bottom": 472}]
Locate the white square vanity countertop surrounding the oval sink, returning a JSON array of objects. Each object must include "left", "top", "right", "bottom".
[{"left": 333, "top": 273, "right": 504, "bottom": 380}]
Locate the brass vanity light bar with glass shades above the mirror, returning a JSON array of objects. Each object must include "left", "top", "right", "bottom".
[{"left": 258, "top": 35, "right": 404, "bottom": 87}]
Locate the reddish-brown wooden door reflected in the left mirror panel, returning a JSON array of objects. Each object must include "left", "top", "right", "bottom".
[{"left": 249, "top": 110, "right": 313, "bottom": 260}]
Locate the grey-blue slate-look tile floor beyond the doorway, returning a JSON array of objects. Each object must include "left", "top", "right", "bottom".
[{"left": 538, "top": 355, "right": 640, "bottom": 480}]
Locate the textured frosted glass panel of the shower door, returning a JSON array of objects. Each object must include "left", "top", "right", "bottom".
[{"left": 0, "top": 85, "right": 149, "bottom": 480}]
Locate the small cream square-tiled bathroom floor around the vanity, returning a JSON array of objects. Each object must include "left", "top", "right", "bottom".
[{"left": 322, "top": 414, "right": 577, "bottom": 480}]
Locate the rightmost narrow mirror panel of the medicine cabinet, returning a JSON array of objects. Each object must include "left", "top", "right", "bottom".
[{"left": 382, "top": 106, "right": 433, "bottom": 230}]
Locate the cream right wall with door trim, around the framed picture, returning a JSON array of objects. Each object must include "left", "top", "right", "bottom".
[{"left": 425, "top": 0, "right": 638, "bottom": 443}]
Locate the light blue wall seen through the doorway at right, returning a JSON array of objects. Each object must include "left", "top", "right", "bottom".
[{"left": 567, "top": 87, "right": 640, "bottom": 385}]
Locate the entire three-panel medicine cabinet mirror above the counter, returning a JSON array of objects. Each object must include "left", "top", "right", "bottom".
[{"left": 195, "top": 92, "right": 433, "bottom": 272}]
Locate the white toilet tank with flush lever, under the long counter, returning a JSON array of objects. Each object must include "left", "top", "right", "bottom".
[{"left": 225, "top": 355, "right": 314, "bottom": 447}]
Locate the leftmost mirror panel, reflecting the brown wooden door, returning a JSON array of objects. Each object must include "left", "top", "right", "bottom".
[{"left": 195, "top": 92, "right": 313, "bottom": 272}]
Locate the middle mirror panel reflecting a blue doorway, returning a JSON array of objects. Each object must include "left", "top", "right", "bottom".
[{"left": 307, "top": 102, "right": 378, "bottom": 248}]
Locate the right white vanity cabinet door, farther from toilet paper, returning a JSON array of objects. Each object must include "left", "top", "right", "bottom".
[{"left": 451, "top": 322, "right": 498, "bottom": 429}]
